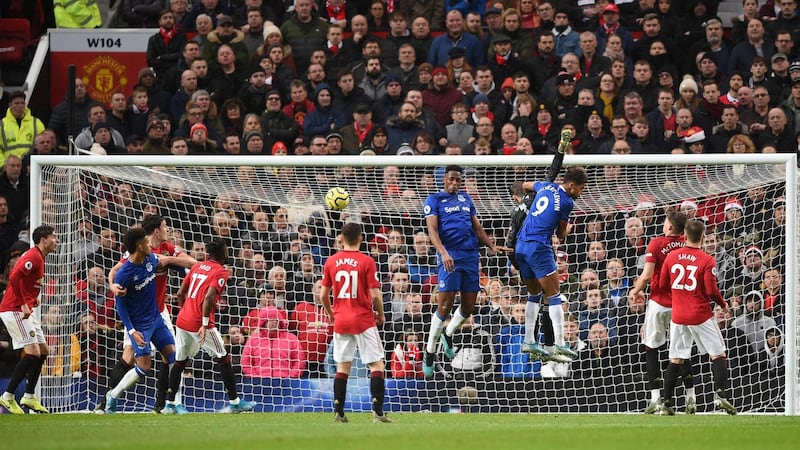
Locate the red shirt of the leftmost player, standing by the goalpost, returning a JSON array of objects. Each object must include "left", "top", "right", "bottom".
[{"left": 0, "top": 247, "right": 44, "bottom": 312}]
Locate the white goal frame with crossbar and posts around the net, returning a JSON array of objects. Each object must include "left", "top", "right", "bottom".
[{"left": 30, "top": 154, "right": 800, "bottom": 416}]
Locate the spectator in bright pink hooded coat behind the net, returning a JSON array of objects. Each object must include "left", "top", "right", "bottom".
[{"left": 242, "top": 306, "right": 306, "bottom": 378}]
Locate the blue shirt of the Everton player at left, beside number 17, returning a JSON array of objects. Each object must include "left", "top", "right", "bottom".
[{"left": 114, "top": 254, "right": 163, "bottom": 331}]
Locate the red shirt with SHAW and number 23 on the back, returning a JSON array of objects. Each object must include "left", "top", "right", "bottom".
[{"left": 661, "top": 247, "right": 725, "bottom": 325}]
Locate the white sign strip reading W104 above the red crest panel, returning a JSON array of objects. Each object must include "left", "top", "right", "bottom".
[{"left": 50, "top": 29, "right": 158, "bottom": 53}]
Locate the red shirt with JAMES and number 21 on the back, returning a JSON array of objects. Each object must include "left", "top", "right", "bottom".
[{"left": 322, "top": 250, "right": 381, "bottom": 334}]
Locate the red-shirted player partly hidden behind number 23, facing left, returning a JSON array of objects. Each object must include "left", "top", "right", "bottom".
[{"left": 628, "top": 211, "right": 697, "bottom": 414}]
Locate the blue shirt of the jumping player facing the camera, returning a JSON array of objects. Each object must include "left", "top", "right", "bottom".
[{"left": 424, "top": 191, "right": 478, "bottom": 253}]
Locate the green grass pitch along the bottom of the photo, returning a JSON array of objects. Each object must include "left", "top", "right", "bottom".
[{"left": 0, "top": 413, "right": 800, "bottom": 450}]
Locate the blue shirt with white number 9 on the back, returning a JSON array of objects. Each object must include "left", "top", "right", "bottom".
[{"left": 518, "top": 181, "right": 575, "bottom": 245}]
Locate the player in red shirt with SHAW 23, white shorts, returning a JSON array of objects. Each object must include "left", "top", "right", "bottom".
[{"left": 659, "top": 219, "right": 736, "bottom": 416}]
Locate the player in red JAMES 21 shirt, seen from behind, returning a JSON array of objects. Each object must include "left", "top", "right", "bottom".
[{"left": 320, "top": 223, "right": 391, "bottom": 422}]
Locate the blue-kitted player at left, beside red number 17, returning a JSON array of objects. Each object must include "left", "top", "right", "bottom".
[{"left": 105, "top": 227, "right": 175, "bottom": 414}]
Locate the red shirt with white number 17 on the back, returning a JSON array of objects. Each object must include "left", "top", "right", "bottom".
[{"left": 176, "top": 260, "right": 228, "bottom": 331}]
